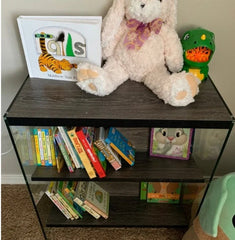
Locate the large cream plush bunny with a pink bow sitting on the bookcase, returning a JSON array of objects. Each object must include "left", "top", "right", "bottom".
[{"left": 77, "top": 0, "right": 200, "bottom": 106}]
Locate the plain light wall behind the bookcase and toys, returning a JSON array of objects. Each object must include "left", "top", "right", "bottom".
[{"left": 1, "top": 0, "right": 235, "bottom": 182}]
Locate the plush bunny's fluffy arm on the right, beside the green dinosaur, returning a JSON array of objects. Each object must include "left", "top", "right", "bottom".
[{"left": 161, "top": 26, "right": 184, "bottom": 72}]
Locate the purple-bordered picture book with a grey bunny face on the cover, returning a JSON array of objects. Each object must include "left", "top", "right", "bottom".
[{"left": 150, "top": 128, "right": 193, "bottom": 160}]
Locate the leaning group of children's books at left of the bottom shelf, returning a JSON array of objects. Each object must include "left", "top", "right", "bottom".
[{"left": 45, "top": 181, "right": 109, "bottom": 220}]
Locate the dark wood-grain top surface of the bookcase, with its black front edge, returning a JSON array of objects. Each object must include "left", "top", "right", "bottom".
[{"left": 5, "top": 78, "right": 233, "bottom": 128}]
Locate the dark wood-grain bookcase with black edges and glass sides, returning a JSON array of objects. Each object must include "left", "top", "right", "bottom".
[{"left": 4, "top": 77, "right": 234, "bottom": 239}]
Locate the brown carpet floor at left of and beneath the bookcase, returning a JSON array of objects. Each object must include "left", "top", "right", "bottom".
[{"left": 1, "top": 185, "right": 185, "bottom": 240}]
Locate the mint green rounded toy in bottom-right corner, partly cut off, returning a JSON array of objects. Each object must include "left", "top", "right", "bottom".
[{"left": 182, "top": 172, "right": 235, "bottom": 240}]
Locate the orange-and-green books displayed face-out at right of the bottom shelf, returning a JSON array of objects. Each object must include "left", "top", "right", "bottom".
[{"left": 140, "top": 182, "right": 205, "bottom": 204}]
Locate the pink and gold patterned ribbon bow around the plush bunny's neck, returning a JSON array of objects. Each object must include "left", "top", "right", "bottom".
[{"left": 124, "top": 18, "right": 163, "bottom": 50}]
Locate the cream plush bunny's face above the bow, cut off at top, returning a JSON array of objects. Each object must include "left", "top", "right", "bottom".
[{"left": 125, "top": 0, "right": 163, "bottom": 23}]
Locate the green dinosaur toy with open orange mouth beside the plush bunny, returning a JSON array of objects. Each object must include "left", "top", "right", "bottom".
[{"left": 181, "top": 28, "right": 215, "bottom": 80}]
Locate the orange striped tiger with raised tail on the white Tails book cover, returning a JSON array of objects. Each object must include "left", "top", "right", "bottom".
[{"left": 38, "top": 32, "right": 77, "bottom": 74}]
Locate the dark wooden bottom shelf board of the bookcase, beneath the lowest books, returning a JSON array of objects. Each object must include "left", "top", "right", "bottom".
[{"left": 38, "top": 195, "right": 189, "bottom": 227}]
